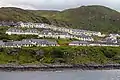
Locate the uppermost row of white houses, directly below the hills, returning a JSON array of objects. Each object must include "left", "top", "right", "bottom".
[{"left": 16, "top": 22, "right": 105, "bottom": 37}]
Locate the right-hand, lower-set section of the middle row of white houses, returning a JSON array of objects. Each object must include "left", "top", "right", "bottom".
[{"left": 39, "top": 30, "right": 94, "bottom": 41}]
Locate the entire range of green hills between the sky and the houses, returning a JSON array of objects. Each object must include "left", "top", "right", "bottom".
[{"left": 0, "top": 5, "right": 120, "bottom": 33}]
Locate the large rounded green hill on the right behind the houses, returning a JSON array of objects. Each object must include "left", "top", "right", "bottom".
[{"left": 34, "top": 5, "right": 120, "bottom": 33}]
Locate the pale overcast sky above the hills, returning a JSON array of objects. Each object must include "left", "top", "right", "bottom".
[{"left": 0, "top": 0, "right": 120, "bottom": 11}]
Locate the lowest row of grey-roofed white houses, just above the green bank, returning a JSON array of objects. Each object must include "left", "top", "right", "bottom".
[{"left": 0, "top": 39, "right": 120, "bottom": 48}]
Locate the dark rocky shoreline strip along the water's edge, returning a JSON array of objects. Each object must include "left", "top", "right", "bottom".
[{"left": 0, "top": 64, "right": 120, "bottom": 71}]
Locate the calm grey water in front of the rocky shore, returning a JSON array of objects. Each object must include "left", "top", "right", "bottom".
[{"left": 0, "top": 70, "right": 120, "bottom": 80}]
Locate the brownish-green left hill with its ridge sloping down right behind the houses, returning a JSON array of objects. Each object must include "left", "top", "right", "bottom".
[{"left": 0, "top": 7, "right": 70, "bottom": 26}]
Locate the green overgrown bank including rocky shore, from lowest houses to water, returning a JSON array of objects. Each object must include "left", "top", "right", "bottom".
[{"left": 0, "top": 46, "right": 120, "bottom": 71}]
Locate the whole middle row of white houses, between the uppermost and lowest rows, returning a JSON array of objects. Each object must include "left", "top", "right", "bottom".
[{"left": 6, "top": 28, "right": 94, "bottom": 41}]
